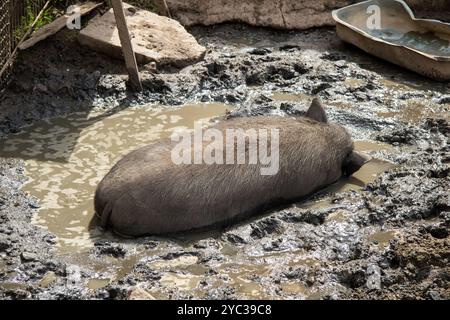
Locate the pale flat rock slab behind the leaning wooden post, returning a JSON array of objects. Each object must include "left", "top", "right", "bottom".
[{"left": 79, "top": 3, "right": 206, "bottom": 67}]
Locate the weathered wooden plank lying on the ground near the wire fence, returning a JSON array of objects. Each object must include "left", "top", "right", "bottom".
[{"left": 19, "top": 2, "right": 103, "bottom": 50}]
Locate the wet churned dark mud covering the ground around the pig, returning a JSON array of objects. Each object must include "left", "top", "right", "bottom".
[{"left": 0, "top": 24, "right": 450, "bottom": 299}]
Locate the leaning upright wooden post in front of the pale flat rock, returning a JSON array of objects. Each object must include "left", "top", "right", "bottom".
[{"left": 111, "top": 0, "right": 142, "bottom": 91}]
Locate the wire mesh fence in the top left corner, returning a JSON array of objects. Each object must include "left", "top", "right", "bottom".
[{"left": 0, "top": 0, "right": 46, "bottom": 90}]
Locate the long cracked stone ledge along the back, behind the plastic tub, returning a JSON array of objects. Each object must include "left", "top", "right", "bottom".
[{"left": 156, "top": 0, "right": 450, "bottom": 29}]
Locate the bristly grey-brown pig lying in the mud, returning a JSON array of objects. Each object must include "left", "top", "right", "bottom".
[{"left": 94, "top": 98, "right": 368, "bottom": 237}]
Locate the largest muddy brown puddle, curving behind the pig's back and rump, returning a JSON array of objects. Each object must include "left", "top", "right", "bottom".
[{"left": 0, "top": 104, "right": 230, "bottom": 253}]
